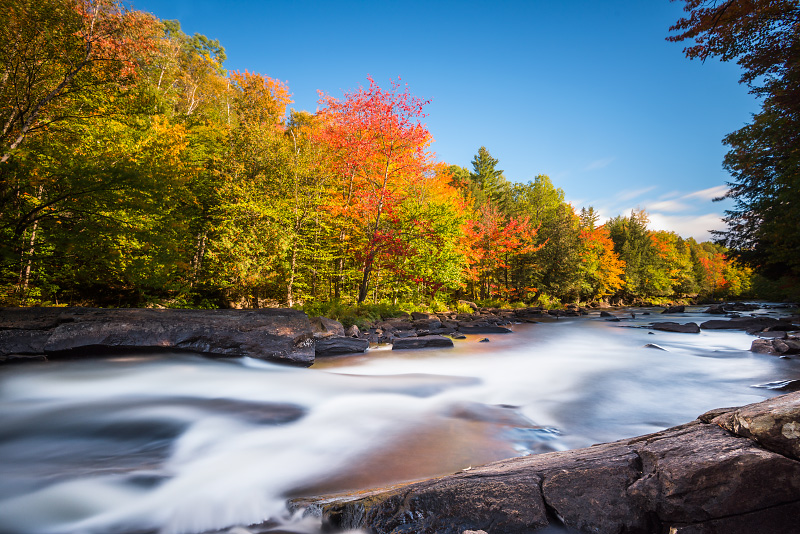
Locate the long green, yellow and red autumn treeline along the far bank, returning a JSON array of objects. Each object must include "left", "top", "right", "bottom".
[{"left": 0, "top": 0, "right": 751, "bottom": 306}]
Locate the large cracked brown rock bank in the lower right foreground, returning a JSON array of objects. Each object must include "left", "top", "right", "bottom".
[{"left": 291, "top": 392, "right": 800, "bottom": 534}]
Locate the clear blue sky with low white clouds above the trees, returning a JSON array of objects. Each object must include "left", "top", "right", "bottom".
[{"left": 132, "top": 0, "right": 760, "bottom": 241}]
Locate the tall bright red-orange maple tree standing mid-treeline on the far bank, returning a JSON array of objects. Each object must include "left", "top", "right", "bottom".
[{"left": 319, "top": 78, "right": 432, "bottom": 302}]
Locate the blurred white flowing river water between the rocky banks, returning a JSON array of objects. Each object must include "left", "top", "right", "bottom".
[{"left": 0, "top": 308, "right": 800, "bottom": 534}]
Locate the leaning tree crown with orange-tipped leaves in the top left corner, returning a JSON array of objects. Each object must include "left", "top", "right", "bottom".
[{"left": 0, "top": 0, "right": 154, "bottom": 163}]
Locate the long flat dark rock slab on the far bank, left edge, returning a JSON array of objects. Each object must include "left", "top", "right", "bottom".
[{"left": 0, "top": 308, "right": 314, "bottom": 366}]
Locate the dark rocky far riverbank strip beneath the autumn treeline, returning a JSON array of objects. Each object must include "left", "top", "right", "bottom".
[{"left": 0, "top": 302, "right": 800, "bottom": 366}]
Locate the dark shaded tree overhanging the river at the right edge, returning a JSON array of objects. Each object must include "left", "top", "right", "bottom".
[{"left": 667, "top": 0, "right": 800, "bottom": 277}]
